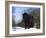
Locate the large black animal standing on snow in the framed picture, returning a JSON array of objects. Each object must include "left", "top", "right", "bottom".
[{"left": 23, "top": 13, "right": 34, "bottom": 29}]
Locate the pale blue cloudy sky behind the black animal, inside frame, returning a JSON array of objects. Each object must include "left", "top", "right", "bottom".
[{"left": 12, "top": 7, "right": 39, "bottom": 24}]
